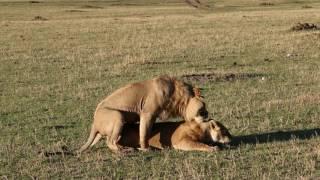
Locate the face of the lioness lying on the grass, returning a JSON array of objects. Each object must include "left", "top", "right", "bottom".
[{"left": 209, "top": 120, "right": 232, "bottom": 144}]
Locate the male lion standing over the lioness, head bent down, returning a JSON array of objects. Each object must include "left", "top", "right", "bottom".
[{"left": 79, "top": 76, "right": 208, "bottom": 153}]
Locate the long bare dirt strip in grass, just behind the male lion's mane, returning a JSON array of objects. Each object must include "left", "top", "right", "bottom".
[{"left": 181, "top": 73, "right": 265, "bottom": 83}]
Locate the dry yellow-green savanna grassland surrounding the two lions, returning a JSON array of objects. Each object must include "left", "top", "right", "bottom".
[{"left": 0, "top": 0, "right": 320, "bottom": 179}]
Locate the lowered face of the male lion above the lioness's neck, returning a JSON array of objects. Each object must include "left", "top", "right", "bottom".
[{"left": 185, "top": 97, "right": 208, "bottom": 122}]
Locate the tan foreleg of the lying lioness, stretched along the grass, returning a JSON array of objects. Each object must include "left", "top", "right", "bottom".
[{"left": 173, "top": 139, "right": 219, "bottom": 152}]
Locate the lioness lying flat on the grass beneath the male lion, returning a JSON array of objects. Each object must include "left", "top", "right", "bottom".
[{"left": 81, "top": 120, "right": 231, "bottom": 151}]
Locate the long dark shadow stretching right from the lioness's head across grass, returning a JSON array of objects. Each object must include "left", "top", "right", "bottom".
[{"left": 230, "top": 128, "right": 320, "bottom": 147}]
